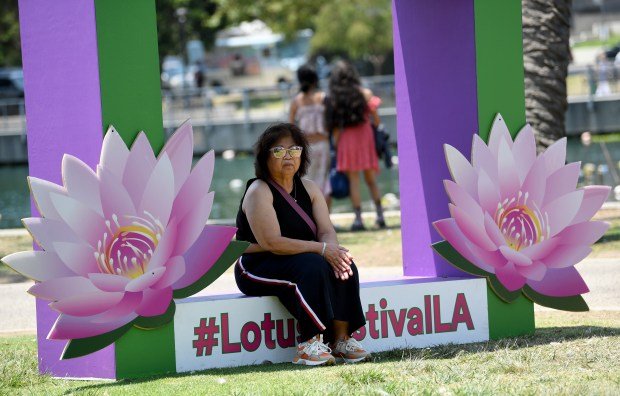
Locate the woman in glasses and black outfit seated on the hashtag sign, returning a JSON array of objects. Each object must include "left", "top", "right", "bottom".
[{"left": 235, "top": 124, "right": 370, "bottom": 365}]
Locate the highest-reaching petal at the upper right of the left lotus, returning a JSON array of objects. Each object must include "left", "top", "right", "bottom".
[{"left": 159, "top": 120, "right": 194, "bottom": 195}]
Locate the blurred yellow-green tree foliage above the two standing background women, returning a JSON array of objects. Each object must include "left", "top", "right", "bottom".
[{"left": 311, "top": 0, "right": 393, "bottom": 74}]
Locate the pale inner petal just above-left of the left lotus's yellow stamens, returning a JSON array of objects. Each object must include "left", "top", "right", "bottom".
[{"left": 98, "top": 167, "right": 136, "bottom": 220}]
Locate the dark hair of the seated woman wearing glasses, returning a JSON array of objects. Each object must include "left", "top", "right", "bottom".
[{"left": 254, "top": 122, "right": 310, "bottom": 180}]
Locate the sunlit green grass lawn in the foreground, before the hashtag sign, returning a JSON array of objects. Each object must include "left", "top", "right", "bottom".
[{"left": 0, "top": 311, "right": 620, "bottom": 395}]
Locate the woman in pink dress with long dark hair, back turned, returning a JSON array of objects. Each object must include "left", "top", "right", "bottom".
[{"left": 325, "top": 62, "right": 385, "bottom": 231}]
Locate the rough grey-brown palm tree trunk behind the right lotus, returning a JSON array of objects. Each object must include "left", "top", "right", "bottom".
[{"left": 521, "top": 0, "right": 571, "bottom": 150}]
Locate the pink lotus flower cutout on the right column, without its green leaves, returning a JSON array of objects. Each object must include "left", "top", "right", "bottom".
[{"left": 433, "top": 114, "right": 610, "bottom": 308}]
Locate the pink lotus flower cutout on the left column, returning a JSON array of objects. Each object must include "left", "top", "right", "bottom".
[{"left": 3, "top": 122, "right": 245, "bottom": 339}]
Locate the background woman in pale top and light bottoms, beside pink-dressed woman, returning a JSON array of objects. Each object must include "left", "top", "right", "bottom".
[{"left": 289, "top": 65, "right": 331, "bottom": 207}]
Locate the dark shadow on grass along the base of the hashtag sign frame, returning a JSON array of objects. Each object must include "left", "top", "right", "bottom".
[{"left": 65, "top": 326, "right": 620, "bottom": 394}]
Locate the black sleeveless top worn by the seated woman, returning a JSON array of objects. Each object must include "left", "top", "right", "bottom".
[{"left": 237, "top": 175, "right": 316, "bottom": 243}]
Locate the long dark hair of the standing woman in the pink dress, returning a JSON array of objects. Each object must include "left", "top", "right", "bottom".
[{"left": 325, "top": 61, "right": 368, "bottom": 130}]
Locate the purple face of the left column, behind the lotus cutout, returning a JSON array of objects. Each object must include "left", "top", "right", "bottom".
[{"left": 19, "top": 0, "right": 115, "bottom": 378}]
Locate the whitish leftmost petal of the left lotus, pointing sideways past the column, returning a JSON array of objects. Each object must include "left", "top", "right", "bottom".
[{"left": 2, "top": 251, "right": 76, "bottom": 282}]
